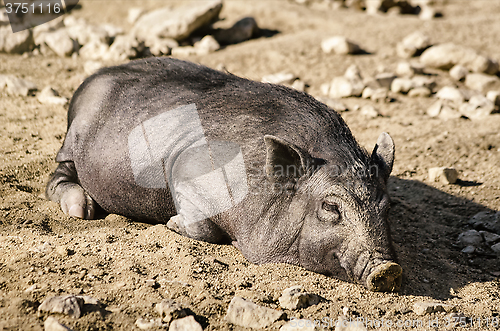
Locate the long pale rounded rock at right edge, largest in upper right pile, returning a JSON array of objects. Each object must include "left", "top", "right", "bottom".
[{"left": 420, "top": 43, "right": 498, "bottom": 75}]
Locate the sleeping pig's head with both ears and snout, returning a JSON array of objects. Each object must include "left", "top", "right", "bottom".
[{"left": 265, "top": 133, "right": 402, "bottom": 291}]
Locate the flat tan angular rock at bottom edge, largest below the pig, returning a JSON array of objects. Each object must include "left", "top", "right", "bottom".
[{"left": 225, "top": 297, "right": 283, "bottom": 329}]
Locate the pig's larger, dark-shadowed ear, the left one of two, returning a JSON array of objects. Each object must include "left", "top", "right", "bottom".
[{"left": 264, "top": 135, "right": 313, "bottom": 178}]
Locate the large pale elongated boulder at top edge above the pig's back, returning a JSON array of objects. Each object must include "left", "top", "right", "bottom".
[{"left": 132, "top": 0, "right": 222, "bottom": 41}]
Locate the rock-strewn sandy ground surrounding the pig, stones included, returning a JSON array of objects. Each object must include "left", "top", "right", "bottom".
[{"left": 0, "top": 0, "right": 500, "bottom": 330}]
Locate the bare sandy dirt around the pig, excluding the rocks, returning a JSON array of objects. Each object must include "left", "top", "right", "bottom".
[{"left": 0, "top": 0, "right": 500, "bottom": 330}]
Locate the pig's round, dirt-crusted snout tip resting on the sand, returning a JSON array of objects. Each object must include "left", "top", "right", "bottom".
[{"left": 366, "top": 262, "right": 403, "bottom": 292}]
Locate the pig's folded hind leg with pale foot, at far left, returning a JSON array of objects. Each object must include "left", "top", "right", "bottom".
[{"left": 45, "top": 161, "right": 97, "bottom": 219}]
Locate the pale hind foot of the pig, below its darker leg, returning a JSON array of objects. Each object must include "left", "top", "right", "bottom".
[{"left": 61, "top": 185, "right": 95, "bottom": 219}]
